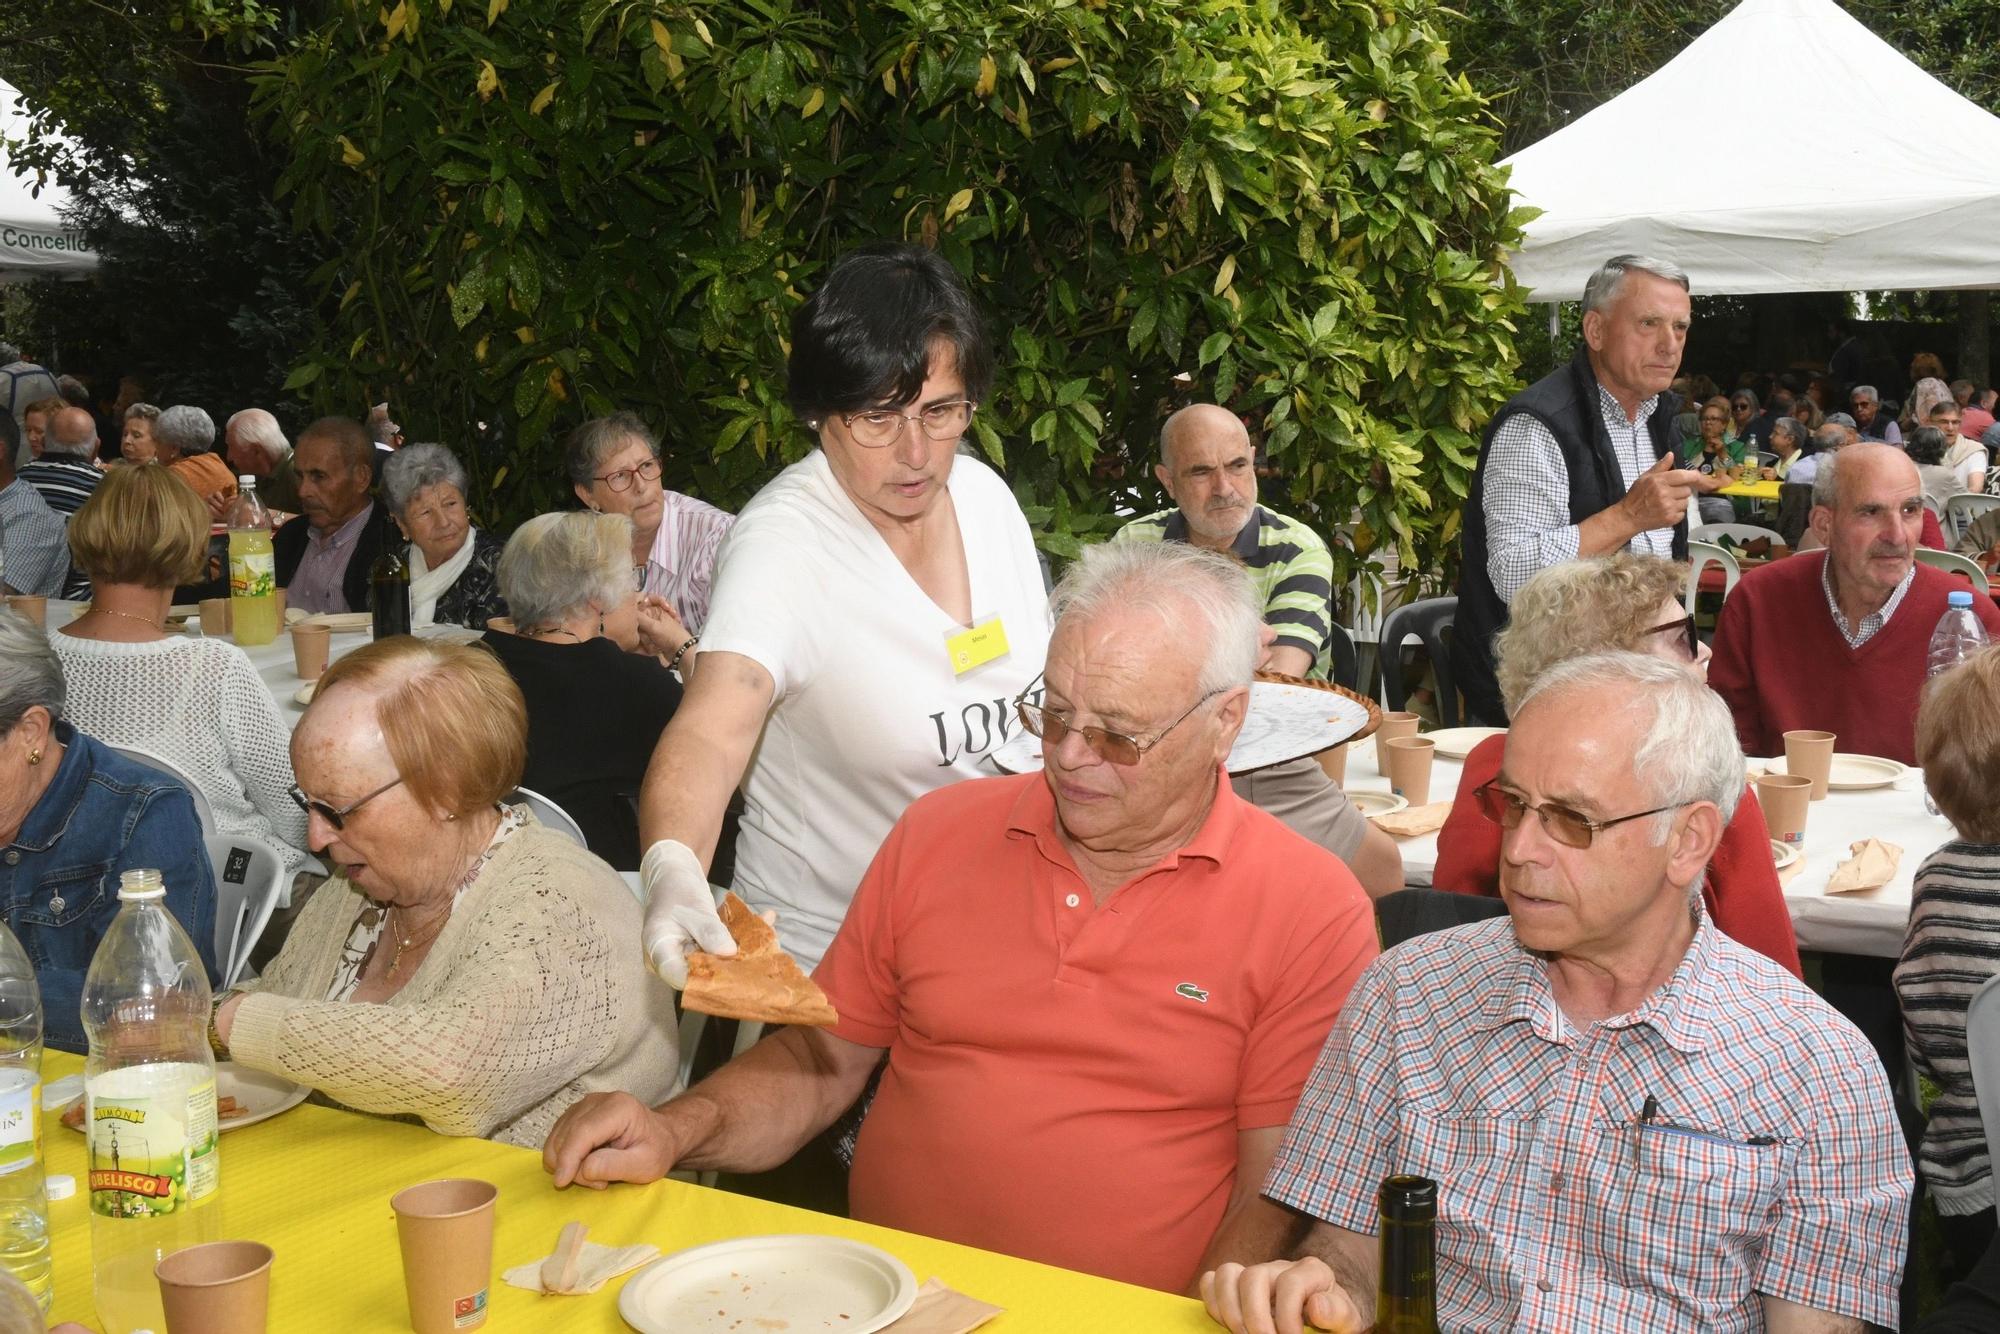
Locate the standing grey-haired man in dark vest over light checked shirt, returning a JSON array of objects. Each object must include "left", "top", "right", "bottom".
[{"left": 1452, "top": 254, "right": 1702, "bottom": 724}]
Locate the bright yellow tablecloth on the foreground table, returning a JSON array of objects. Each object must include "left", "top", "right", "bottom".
[{"left": 42, "top": 1052, "right": 1218, "bottom": 1334}]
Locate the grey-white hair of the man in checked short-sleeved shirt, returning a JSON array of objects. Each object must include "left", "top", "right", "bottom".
[{"left": 1522, "top": 652, "right": 1744, "bottom": 852}]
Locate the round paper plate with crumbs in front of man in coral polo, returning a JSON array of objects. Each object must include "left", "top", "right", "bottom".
[{"left": 618, "top": 1236, "right": 916, "bottom": 1334}]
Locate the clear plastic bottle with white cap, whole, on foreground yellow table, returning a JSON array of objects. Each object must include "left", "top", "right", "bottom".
[{"left": 82, "top": 870, "right": 222, "bottom": 1334}]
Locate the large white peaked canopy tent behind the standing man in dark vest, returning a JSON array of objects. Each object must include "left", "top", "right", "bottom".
[{"left": 1502, "top": 0, "right": 2000, "bottom": 302}]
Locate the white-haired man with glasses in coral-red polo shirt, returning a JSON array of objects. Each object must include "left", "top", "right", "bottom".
[{"left": 542, "top": 542, "right": 1376, "bottom": 1290}]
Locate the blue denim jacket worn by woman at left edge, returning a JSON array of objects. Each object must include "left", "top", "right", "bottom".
[{"left": 0, "top": 722, "right": 216, "bottom": 1052}]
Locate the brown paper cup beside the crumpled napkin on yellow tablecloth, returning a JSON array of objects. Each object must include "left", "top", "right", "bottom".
[{"left": 388, "top": 1176, "right": 500, "bottom": 1334}]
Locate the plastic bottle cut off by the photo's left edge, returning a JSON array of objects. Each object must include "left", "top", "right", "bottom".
[{"left": 0, "top": 922, "right": 54, "bottom": 1328}]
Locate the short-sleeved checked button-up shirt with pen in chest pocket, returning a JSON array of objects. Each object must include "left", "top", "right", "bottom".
[{"left": 1266, "top": 916, "right": 1910, "bottom": 1332}]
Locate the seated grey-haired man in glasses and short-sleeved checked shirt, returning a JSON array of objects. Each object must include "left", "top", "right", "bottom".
[{"left": 1202, "top": 654, "right": 1910, "bottom": 1334}]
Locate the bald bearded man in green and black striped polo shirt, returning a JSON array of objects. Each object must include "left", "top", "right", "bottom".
[{"left": 1112, "top": 404, "right": 1402, "bottom": 896}]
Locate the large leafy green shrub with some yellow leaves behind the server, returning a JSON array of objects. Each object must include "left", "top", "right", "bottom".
[{"left": 258, "top": 0, "right": 1520, "bottom": 588}]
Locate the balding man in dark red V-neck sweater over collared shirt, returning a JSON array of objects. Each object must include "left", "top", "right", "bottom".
[{"left": 1708, "top": 442, "right": 2000, "bottom": 764}]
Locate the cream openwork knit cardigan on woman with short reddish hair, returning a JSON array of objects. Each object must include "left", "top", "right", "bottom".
[{"left": 230, "top": 824, "right": 678, "bottom": 1148}]
